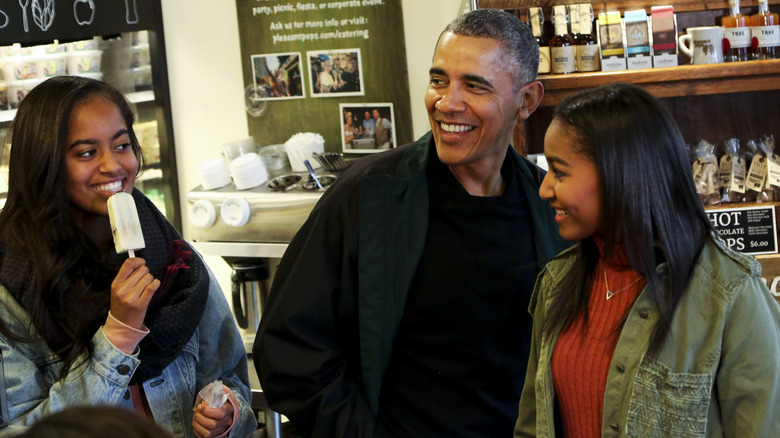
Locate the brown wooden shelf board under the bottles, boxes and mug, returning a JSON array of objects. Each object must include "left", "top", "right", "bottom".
[{"left": 539, "top": 59, "right": 780, "bottom": 106}]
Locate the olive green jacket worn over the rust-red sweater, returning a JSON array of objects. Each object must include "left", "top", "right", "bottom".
[{"left": 515, "top": 236, "right": 780, "bottom": 438}]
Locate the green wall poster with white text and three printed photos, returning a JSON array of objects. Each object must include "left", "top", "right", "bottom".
[{"left": 235, "top": 0, "right": 412, "bottom": 153}]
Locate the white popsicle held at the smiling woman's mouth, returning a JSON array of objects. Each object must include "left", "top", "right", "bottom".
[{"left": 108, "top": 192, "right": 146, "bottom": 257}]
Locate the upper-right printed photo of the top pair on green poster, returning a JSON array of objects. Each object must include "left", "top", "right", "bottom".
[{"left": 306, "top": 49, "right": 365, "bottom": 97}]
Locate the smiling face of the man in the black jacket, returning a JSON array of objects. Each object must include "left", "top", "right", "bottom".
[{"left": 425, "top": 32, "right": 525, "bottom": 169}]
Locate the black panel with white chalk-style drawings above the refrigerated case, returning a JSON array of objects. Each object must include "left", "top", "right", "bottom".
[{"left": 0, "top": 0, "right": 160, "bottom": 45}]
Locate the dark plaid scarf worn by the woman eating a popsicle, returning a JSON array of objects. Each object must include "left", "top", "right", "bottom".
[{"left": 0, "top": 190, "right": 209, "bottom": 383}]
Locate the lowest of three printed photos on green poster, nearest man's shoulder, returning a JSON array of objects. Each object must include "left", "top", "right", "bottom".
[{"left": 339, "top": 103, "right": 397, "bottom": 154}]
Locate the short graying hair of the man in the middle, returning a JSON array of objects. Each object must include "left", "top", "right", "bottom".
[{"left": 439, "top": 9, "right": 539, "bottom": 91}]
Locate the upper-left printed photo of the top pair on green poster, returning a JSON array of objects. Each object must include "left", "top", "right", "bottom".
[{"left": 252, "top": 53, "right": 305, "bottom": 100}]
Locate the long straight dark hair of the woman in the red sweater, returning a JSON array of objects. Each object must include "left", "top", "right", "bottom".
[{"left": 548, "top": 84, "right": 712, "bottom": 354}]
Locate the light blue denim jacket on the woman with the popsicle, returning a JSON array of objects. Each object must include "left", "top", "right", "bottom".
[{"left": 0, "top": 272, "right": 257, "bottom": 438}]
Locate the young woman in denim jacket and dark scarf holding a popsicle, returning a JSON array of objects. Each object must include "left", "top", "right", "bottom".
[{"left": 0, "top": 76, "right": 256, "bottom": 437}]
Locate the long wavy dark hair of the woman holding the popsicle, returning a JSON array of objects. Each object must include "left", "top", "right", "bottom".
[{"left": 0, "top": 76, "right": 143, "bottom": 378}]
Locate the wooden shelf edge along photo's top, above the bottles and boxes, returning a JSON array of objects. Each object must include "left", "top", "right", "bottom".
[{"left": 477, "top": 0, "right": 780, "bottom": 15}]
